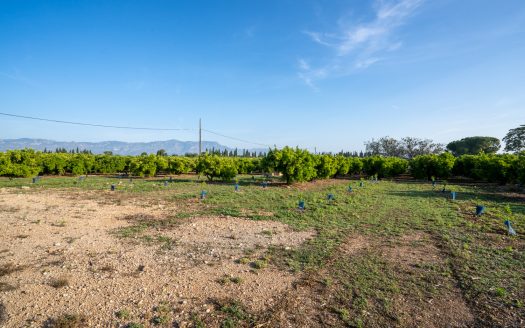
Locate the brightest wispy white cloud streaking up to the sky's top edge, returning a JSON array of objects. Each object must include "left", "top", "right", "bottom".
[{"left": 298, "top": 0, "right": 424, "bottom": 90}]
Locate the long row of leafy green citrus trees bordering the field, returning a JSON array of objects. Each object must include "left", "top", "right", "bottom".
[{"left": 0, "top": 147, "right": 525, "bottom": 183}]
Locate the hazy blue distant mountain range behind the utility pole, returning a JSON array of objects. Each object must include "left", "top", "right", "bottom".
[{"left": 0, "top": 138, "right": 267, "bottom": 155}]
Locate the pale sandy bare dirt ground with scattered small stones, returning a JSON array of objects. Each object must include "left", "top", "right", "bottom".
[{"left": 0, "top": 189, "right": 313, "bottom": 327}]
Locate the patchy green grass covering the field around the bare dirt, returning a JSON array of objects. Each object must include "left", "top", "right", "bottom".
[{"left": 0, "top": 176, "right": 525, "bottom": 326}]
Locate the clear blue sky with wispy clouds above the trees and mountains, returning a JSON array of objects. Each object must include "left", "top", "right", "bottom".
[{"left": 0, "top": 0, "right": 525, "bottom": 151}]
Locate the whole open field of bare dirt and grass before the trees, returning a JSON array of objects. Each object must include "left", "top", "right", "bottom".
[{"left": 0, "top": 175, "right": 525, "bottom": 327}]
